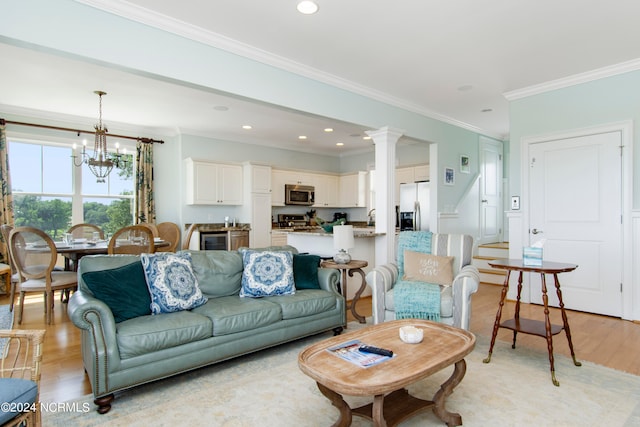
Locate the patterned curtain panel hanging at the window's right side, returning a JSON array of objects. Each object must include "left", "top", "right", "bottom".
[{"left": 136, "top": 141, "right": 156, "bottom": 224}]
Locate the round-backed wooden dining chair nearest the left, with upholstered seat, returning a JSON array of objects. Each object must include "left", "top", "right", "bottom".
[{"left": 9, "top": 227, "right": 78, "bottom": 325}]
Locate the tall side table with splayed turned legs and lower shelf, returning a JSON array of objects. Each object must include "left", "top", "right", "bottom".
[{"left": 483, "top": 259, "right": 582, "bottom": 386}]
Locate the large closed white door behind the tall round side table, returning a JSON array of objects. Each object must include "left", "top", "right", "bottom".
[{"left": 529, "top": 132, "right": 622, "bottom": 316}]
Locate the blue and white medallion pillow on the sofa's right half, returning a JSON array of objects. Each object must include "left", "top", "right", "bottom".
[{"left": 240, "top": 250, "right": 296, "bottom": 298}]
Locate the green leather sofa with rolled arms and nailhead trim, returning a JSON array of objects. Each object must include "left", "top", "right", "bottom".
[{"left": 68, "top": 246, "right": 345, "bottom": 413}]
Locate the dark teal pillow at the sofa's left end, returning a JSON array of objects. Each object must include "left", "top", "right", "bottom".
[{"left": 82, "top": 262, "right": 151, "bottom": 323}]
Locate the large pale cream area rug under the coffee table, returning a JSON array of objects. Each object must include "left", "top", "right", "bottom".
[{"left": 42, "top": 324, "right": 640, "bottom": 427}]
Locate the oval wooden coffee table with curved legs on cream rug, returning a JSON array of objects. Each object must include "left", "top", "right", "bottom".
[{"left": 298, "top": 319, "right": 476, "bottom": 426}]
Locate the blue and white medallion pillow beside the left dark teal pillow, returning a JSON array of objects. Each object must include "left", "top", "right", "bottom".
[{"left": 140, "top": 252, "right": 207, "bottom": 314}]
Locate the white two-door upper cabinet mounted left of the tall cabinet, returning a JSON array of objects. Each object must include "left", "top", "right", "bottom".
[{"left": 185, "top": 158, "right": 243, "bottom": 205}]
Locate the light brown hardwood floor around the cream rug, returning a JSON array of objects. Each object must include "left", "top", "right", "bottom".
[{"left": 0, "top": 284, "right": 640, "bottom": 402}]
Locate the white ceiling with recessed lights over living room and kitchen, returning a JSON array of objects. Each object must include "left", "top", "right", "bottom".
[{"left": 0, "top": 0, "right": 640, "bottom": 155}]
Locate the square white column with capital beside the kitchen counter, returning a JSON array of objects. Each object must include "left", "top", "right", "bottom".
[{"left": 367, "top": 127, "right": 403, "bottom": 265}]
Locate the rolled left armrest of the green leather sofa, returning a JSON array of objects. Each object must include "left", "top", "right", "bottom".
[{"left": 67, "top": 291, "right": 120, "bottom": 382}]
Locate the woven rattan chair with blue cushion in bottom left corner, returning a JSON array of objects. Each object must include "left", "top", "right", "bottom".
[{"left": 0, "top": 329, "right": 45, "bottom": 427}]
